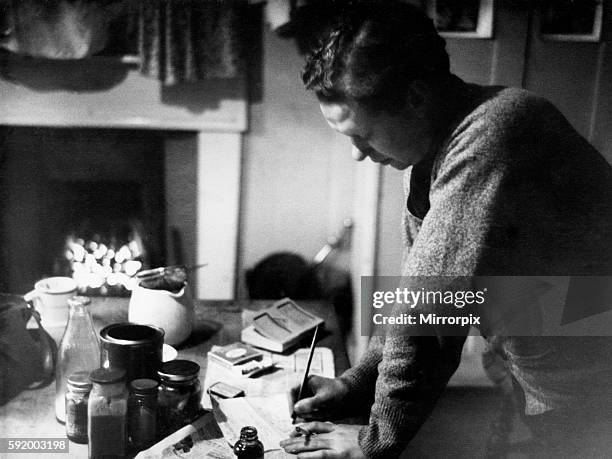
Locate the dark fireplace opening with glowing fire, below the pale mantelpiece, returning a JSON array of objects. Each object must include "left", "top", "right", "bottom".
[{"left": 1, "top": 127, "right": 167, "bottom": 295}]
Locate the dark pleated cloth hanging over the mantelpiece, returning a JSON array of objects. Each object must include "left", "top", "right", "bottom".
[{"left": 135, "top": 0, "right": 247, "bottom": 85}]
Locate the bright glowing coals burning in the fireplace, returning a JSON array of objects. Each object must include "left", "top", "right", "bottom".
[{"left": 64, "top": 235, "right": 144, "bottom": 295}]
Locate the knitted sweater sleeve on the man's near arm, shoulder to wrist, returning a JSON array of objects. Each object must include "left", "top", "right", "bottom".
[{"left": 359, "top": 99, "right": 532, "bottom": 458}]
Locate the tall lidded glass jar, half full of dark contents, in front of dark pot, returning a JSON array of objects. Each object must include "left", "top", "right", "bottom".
[{"left": 87, "top": 368, "right": 128, "bottom": 459}]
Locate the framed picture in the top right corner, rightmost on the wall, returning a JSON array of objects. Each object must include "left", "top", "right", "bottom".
[{"left": 539, "top": 0, "right": 603, "bottom": 41}]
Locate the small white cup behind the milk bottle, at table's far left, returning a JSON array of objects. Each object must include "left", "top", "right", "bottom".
[{"left": 23, "top": 277, "right": 77, "bottom": 327}]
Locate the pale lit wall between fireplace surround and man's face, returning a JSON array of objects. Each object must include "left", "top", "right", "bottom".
[{"left": 239, "top": 27, "right": 355, "bottom": 295}]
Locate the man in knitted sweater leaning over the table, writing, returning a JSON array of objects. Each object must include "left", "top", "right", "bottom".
[{"left": 281, "top": 1, "right": 612, "bottom": 458}]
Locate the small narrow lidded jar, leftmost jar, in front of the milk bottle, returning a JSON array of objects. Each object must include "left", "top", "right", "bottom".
[{"left": 66, "top": 371, "right": 91, "bottom": 444}]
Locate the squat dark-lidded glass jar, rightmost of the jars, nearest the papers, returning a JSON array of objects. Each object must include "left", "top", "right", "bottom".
[{"left": 157, "top": 360, "right": 202, "bottom": 437}]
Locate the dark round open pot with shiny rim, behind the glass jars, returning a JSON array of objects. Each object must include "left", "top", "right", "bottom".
[{"left": 100, "top": 322, "right": 164, "bottom": 381}]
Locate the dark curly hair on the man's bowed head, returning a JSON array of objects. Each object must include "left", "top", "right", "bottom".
[{"left": 302, "top": 0, "right": 450, "bottom": 112}]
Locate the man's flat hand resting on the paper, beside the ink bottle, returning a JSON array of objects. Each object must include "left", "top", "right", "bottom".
[{"left": 280, "top": 422, "right": 365, "bottom": 459}]
